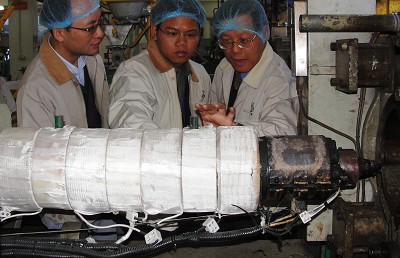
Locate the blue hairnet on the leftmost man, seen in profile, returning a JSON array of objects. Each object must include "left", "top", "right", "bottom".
[{"left": 39, "top": 0, "right": 100, "bottom": 29}]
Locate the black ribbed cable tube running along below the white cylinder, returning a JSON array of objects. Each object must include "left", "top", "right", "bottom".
[{"left": 0, "top": 226, "right": 263, "bottom": 258}]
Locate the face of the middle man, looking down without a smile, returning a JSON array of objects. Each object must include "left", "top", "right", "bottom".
[{"left": 151, "top": 16, "right": 200, "bottom": 67}]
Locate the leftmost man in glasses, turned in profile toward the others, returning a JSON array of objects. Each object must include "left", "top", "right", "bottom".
[{"left": 17, "top": 0, "right": 109, "bottom": 128}]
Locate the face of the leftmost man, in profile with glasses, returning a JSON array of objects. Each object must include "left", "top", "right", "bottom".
[{"left": 63, "top": 10, "right": 105, "bottom": 60}]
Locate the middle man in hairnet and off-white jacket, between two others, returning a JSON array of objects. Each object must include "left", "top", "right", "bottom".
[{"left": 109, "top": 0, "right": 211, "bottom": 129}]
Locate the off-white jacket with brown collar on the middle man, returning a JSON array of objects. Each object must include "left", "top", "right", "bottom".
[{"left": 109, "top": 41, "right": 211, "bottom": 129}]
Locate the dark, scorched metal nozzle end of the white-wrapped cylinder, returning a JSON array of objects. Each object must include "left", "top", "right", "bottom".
[{"left": 259, "top": 135, "right": 380, "bottom": 199}]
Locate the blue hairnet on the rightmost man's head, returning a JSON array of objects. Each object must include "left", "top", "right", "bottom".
[{"left": 213, "top": 0, "right": 268, "bottom": 42}]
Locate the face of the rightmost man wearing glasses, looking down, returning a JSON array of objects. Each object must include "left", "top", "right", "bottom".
[{"left": 220, "top": 30, "right": 265, "bottom": 73}]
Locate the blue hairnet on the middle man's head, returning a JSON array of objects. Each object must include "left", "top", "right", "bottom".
[{"left": 150, "top": 0, "right": 206, "bottom": 27}]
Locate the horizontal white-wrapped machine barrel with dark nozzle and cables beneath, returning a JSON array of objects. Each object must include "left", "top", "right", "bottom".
[{"left": 0, "top": 126, "right": 380, "bottom": 256}]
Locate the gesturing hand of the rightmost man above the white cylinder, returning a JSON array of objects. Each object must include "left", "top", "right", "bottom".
[{"left": 195, "top": 103, "right": 235, "bottom": 127}]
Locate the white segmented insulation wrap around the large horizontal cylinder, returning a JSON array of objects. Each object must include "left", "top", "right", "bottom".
[{"left": 0, "top": 126, "right": 260, "bottom": 215}]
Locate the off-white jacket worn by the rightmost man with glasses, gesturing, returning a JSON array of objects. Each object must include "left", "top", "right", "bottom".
[{"left": 210, "top": 44, "right": 299, "bottom": 137}]
